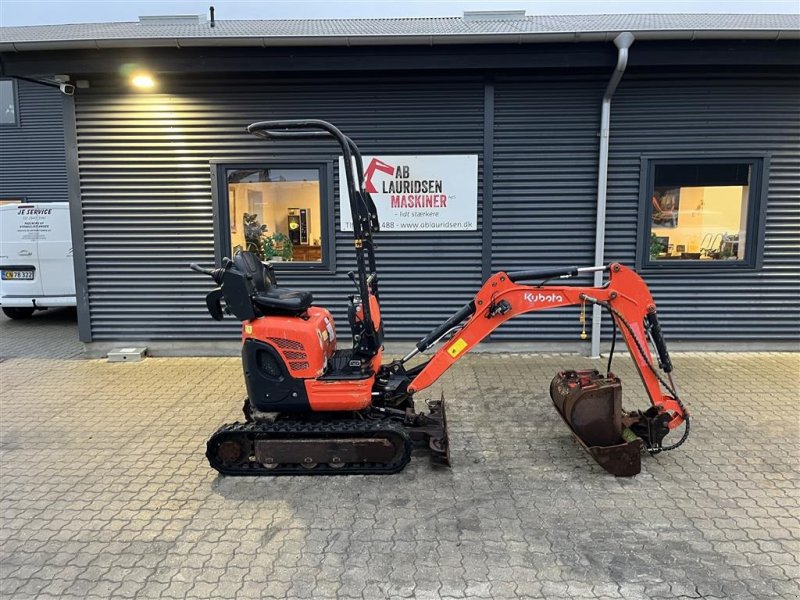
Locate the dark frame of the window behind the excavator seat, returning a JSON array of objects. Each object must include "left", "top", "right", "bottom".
[{"left": 210, "top": 156, "right": 336, "bottom": 274}]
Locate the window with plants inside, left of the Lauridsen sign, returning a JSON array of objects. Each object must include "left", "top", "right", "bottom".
[{"left": 212, "top": 164, "right": 333, "bottom": 268}]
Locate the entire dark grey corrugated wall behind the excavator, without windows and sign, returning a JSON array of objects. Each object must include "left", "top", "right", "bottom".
[{"left": 76, "top": 72, "right": 800, "bottom": 341}]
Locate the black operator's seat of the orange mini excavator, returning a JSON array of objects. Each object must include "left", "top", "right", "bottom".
[{"left": 233, "top": 252, "right": 314, "bottom": 315}]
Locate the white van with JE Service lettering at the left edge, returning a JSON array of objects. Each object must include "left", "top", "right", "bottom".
[{"left": 0, "top": 202, "right": 76, "bottom": 319}]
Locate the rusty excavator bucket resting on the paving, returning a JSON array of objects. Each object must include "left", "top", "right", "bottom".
[{"left": 550, "top": 369, "right": 644, "bottom": 477}]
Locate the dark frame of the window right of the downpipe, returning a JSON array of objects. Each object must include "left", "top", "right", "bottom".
[{"left": 636, "top": 152, "right": 770, "bottom": 272}]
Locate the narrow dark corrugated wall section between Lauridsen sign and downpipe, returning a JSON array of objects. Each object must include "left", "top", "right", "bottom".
[{"left": 492, "top": 76, "right": 605, "bottom": 341}]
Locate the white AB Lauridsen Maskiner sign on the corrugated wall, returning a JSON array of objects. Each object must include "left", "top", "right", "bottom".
[{"left": 339, "top": 154, "right": 478, "bottom": 231}]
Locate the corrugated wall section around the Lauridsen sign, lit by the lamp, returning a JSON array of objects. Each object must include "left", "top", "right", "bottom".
[{"left": 76, "top": 76, "right": 484, "bottom": 341}]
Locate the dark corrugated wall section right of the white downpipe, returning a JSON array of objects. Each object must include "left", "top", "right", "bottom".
[{"left": 606, "top": 73, "right": 800, "bottom": 340}]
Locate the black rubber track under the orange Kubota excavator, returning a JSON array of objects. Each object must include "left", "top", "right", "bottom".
[{"left": 206, "top": 419, "right": 412, "bottom": 477}]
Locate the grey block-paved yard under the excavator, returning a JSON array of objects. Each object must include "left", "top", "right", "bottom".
[{"left": 0, "top": 321, "right": 800, "bottom": 600}]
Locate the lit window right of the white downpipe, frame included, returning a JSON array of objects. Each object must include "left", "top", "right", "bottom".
[{"left": 639, "top": 158, "right": 763, "bottom": 268}]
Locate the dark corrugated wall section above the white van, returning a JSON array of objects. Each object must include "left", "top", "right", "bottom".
[{"left": 0, "top": 81, "right": 67, "bottom": 202}]
